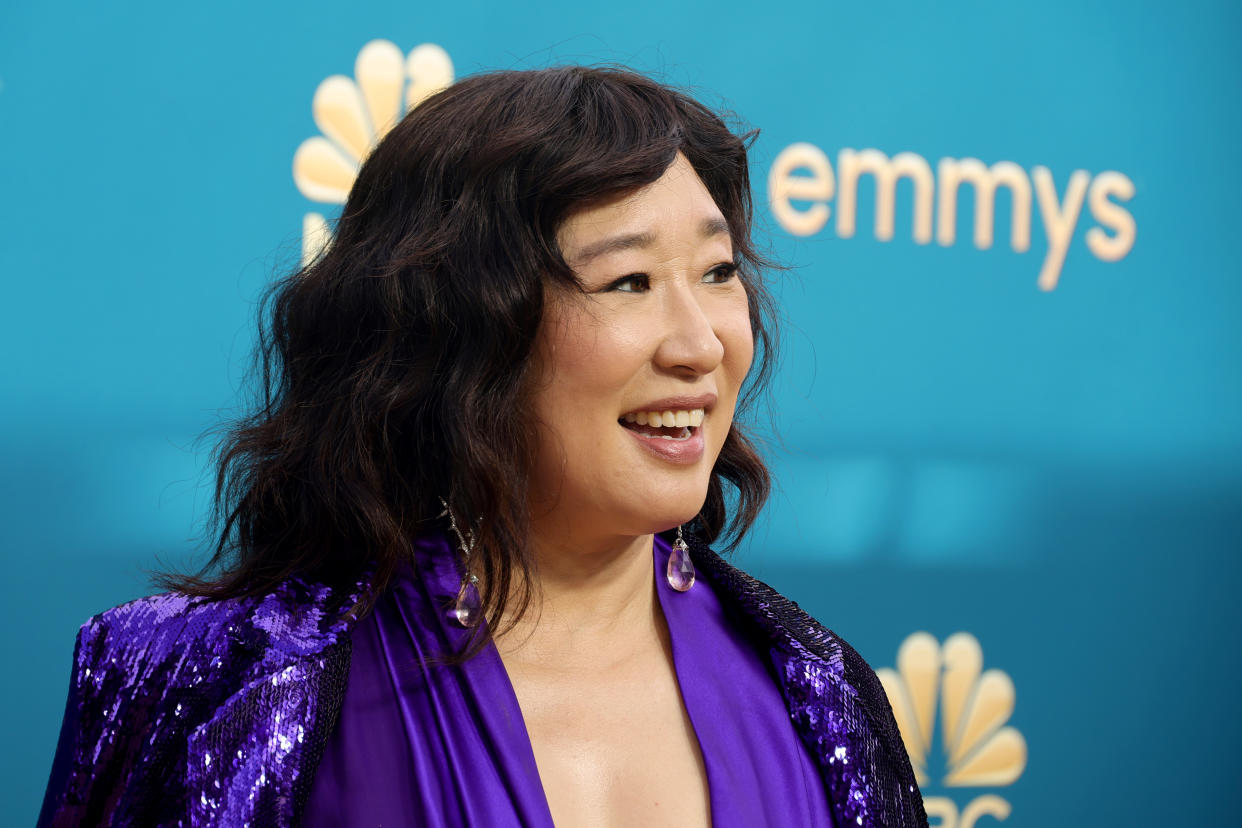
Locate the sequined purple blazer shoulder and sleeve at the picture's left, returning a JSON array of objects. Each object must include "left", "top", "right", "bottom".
[{"left": 40, "top": 580, "right": 354, "bottom": 828}]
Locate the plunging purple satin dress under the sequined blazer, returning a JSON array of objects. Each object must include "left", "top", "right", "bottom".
[{"left": 304, "top": 536, "right": 833, "bottom": 828}]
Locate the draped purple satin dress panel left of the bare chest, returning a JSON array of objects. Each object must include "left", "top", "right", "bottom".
[{"left": 303, "top": 536, "right": 553, "bottom": 828}]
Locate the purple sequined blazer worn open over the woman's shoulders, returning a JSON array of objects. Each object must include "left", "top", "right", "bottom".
[{"left": 39, "top": 544, "right": 927, "bottom": 828}]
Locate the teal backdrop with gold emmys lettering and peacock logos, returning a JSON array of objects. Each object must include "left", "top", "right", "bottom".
[{"left": 0, "top": 0, "right": 1242, "bottom": 828}]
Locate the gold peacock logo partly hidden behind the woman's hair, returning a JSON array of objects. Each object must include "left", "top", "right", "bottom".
[{"left": 293, "top": 40, "right": 453, "bottom": 264}]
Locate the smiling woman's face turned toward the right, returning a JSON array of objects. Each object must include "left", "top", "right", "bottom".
[{"left": 532, "top": 154, "right": 754, "bottom": 541}]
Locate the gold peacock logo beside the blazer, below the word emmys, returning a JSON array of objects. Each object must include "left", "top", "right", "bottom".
[{"left": 876, "top": 632, "right": 1026, "bottom": 828}]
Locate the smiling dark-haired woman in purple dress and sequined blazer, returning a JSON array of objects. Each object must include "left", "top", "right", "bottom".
[{"left": 41, "top": 67, "right": 925, "bottom": 826}]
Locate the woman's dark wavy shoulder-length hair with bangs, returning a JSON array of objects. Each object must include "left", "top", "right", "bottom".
[{"left": 161, "top": 66, "right": 774, "bottom": 635}]
